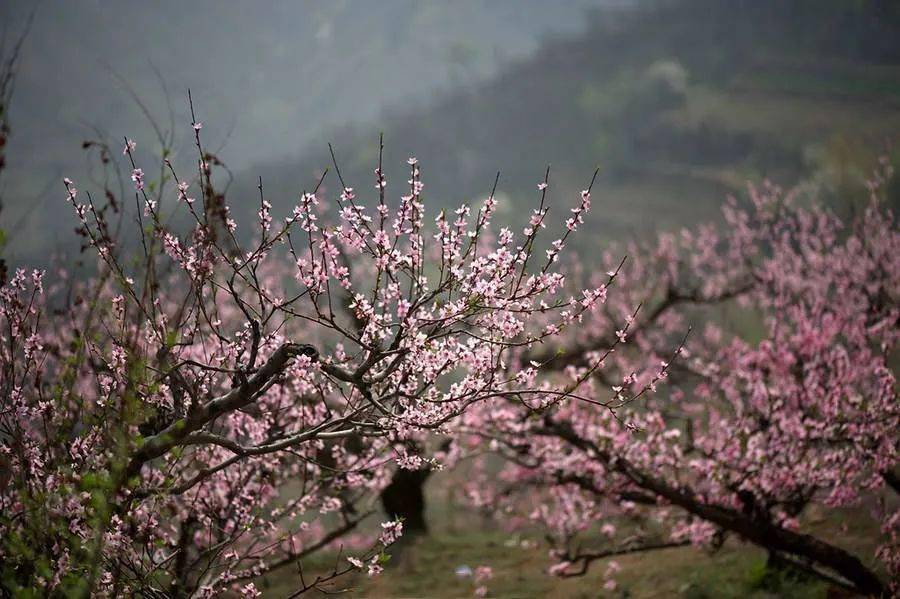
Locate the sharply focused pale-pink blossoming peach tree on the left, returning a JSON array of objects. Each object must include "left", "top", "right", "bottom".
[{"left": 0, "top": 119, "right": 605, "bottom": 596}]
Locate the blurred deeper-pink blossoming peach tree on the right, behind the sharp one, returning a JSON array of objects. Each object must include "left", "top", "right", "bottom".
[{"left": 457, "top": 173, "right": 900, "bottom": 596}]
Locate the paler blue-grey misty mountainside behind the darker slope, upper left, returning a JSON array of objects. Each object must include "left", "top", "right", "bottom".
[{"left": 0, "top": 0, "right": 623, "bottom": 261}]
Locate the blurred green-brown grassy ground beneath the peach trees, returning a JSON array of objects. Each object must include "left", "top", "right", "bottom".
[{"left": 257, "top": 481, "right": 878, "bottom": 599}]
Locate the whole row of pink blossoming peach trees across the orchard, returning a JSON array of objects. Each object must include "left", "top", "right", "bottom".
[{"left": 0, "top": 109, "right": 900, "bottom": 597}]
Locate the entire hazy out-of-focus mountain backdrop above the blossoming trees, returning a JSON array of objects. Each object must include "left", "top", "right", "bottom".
[{"left": 7, "top": 0, "right": 900, "bottom": 263}]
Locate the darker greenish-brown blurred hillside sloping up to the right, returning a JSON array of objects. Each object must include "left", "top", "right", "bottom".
[{"left": 232, "top": 0, "right": 900, "bottom": 246}]
